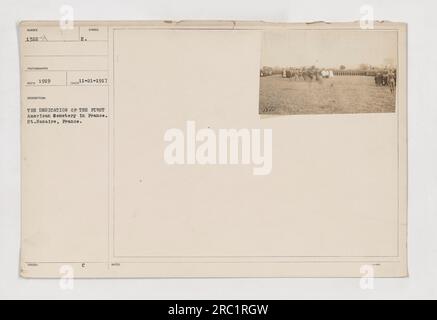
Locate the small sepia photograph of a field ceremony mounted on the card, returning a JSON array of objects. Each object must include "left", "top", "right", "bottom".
[{"left": 259, "top": 29, "right": 398, "bottom": 115}]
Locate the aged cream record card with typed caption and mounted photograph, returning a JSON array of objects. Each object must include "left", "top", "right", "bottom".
[{"left": 19, "top": 21, "right": 407, "bottom": 277}]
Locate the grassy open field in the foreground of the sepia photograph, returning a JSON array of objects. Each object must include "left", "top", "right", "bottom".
[{"left": 259, "top": 74, "right": 396, "bottom": 114}]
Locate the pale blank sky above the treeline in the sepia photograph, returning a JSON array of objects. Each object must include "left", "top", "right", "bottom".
[{"left": 261, "top": 30, "right": 397, "bottom": 68}]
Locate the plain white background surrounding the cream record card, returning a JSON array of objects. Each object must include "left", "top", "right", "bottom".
[{"left": 0, "top": 0, "right": 437, "bottom": 299}]
